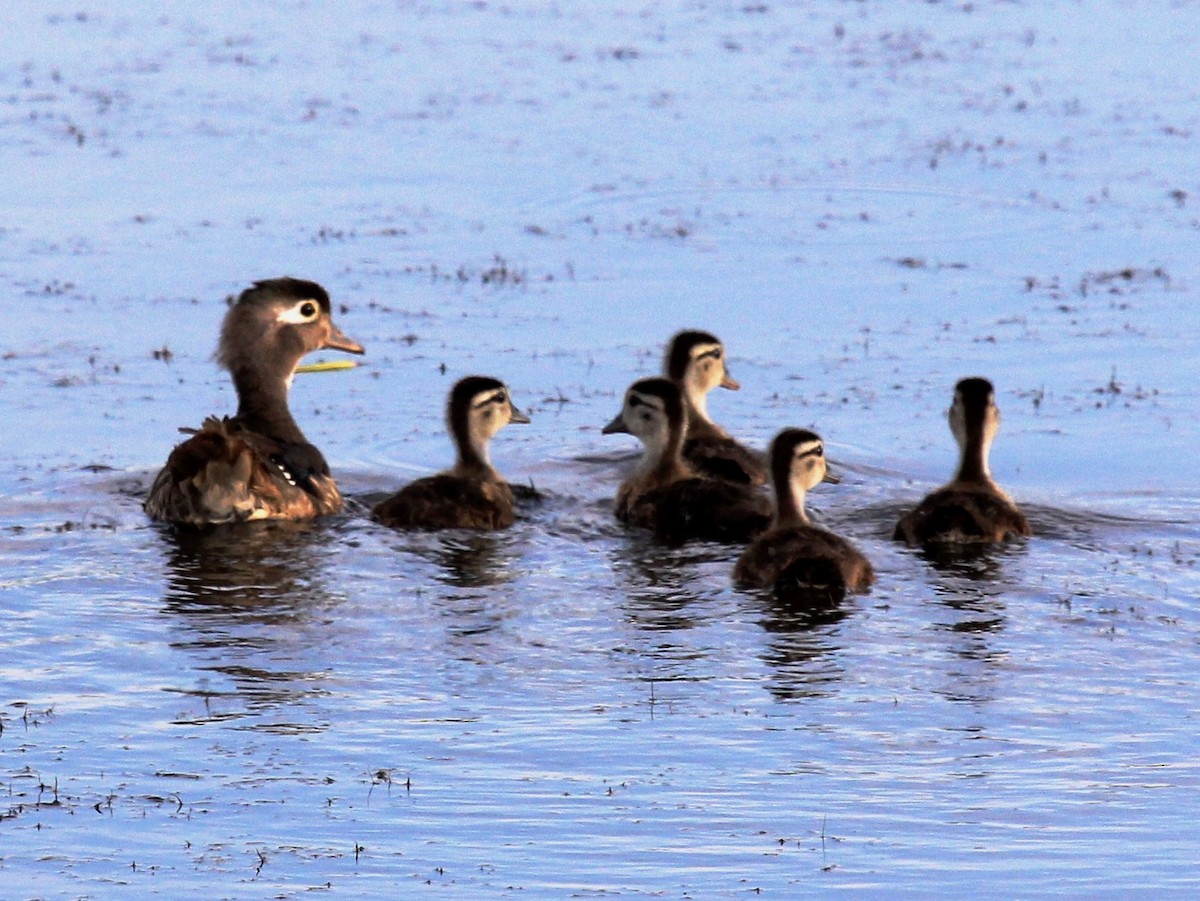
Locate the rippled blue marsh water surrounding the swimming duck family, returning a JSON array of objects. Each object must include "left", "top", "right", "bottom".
[{"left": 0, "top": 2, "right": 1200, "bottom": 899}]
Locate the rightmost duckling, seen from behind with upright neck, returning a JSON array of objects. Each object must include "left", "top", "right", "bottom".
[{"left": 894, "top": 378, "right": 1031, "bottom": 546}]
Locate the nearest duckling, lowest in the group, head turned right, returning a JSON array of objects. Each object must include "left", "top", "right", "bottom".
[{"left": 733, "top": 428, "right": 875, "bottom": 593}]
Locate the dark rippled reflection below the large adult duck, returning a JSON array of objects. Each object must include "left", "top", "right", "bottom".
[{"left": 150, "top": 522, "right": 341, "bottom": 732}]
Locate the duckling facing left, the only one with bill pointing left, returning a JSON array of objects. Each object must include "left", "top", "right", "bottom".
[{"left": 604, "top": 377, "right": 770, "bottom": 545}]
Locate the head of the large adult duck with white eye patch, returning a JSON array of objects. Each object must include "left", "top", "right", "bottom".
[{"left": 217, "top": 277, "right": 362, "bottom": 384}]
